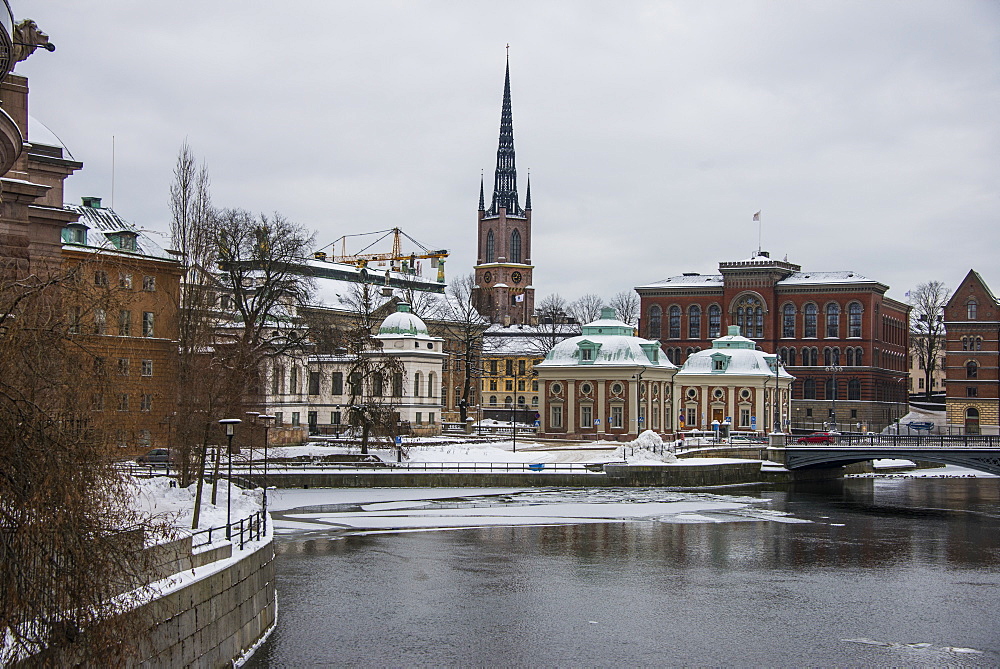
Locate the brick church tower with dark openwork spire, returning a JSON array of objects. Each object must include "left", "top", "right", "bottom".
[{"left": 473, "top": 59, "right": 535, "bottom": 325}]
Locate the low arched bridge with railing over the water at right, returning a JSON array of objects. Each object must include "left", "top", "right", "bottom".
[{"left": 784, "top": 435, "right": 1000, "bottom": 476}]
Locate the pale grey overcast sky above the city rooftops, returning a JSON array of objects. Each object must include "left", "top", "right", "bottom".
[{"left": 12, "top": 0, "right": 1000, "bottom": 299}]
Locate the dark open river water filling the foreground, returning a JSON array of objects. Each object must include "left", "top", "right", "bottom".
[{"left": 249, "top": 478, "right": 1000, "bottom": 667}]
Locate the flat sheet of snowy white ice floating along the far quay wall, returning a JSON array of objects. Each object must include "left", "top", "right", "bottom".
[{"left": 273, "top": 488, "right": 810, "bottom": 537}]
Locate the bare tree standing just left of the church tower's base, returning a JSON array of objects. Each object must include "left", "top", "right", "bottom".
[{"left": 433, "top": 274, "right": 489, "bottom": 423}]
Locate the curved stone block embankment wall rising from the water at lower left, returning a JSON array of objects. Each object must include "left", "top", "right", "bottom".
[{"left": 130, "top": 541, "right": 277, "bottom": 667}]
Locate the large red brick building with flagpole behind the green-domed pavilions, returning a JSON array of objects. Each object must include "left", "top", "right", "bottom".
[{"left": 636, "top": 252, "right": 910, "bottom": 431}]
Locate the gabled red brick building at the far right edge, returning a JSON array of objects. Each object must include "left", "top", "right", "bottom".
[{"left": 944, "top": 270, "right": 1000, "bottom": 434}]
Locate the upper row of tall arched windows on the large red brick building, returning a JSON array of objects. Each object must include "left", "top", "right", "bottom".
[{"left": 646, "top": 295, "right": 863, "bottom": 339}]
